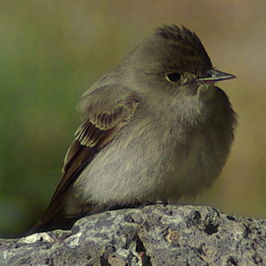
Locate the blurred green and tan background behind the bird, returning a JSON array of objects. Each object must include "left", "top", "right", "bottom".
[{"left": 0, "top": 0, "right": 266, "bottom": 237}]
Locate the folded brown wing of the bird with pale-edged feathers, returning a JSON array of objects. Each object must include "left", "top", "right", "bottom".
[{"left": 32, "top": 86, "right": 140, "bottom": 231}]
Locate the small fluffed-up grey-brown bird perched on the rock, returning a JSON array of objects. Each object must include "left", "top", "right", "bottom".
[{"left": 31, "top": 25, "right": 236, "bottom": 232}]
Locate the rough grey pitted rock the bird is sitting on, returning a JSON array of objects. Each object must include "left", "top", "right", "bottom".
[{"left": 0, "top": 205, "right": 266, "bottom": 266}]
